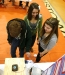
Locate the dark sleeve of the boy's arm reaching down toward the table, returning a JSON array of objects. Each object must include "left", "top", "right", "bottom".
[{"left": 26, "top": 25, "right": 32, "bottom": 52}]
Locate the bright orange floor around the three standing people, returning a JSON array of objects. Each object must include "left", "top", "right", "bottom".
[{"left": 0, "top": 0, "right": 65, "bottom": 64}]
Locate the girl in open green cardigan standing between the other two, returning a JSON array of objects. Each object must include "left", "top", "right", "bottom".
[{"left": 24, "top": 3, "right": 42, "bottom": 51}]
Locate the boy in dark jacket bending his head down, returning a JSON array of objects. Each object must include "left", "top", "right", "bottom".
[{"left": 7, "top": 18, "right": 32, "bottom": 57}]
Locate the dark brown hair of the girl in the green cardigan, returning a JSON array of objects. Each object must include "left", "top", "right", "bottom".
[{"left": 27, "top": 3, "right": 40, "bottom": 20}]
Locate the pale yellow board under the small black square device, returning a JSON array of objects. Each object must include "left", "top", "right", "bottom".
[{"left": 4, "top": 58, "right": 25, "bottom": 75}]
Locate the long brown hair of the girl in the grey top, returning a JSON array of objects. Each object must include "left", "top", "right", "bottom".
[{"left": 40, "top": 17, "right": 59, "bottom": 44}]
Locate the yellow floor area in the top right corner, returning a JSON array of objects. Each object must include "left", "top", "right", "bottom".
[{"left": 48, "top": 0, "right": 65, "bottom": 22}]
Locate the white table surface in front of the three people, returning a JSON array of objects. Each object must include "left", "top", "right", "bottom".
[{"left": 0, "top": 61, "right": 55, "bottom": 71}]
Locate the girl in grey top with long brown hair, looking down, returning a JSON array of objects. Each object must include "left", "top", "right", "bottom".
[{"left": 36, "top": 17, "right": 59, "bottom": 62}]
